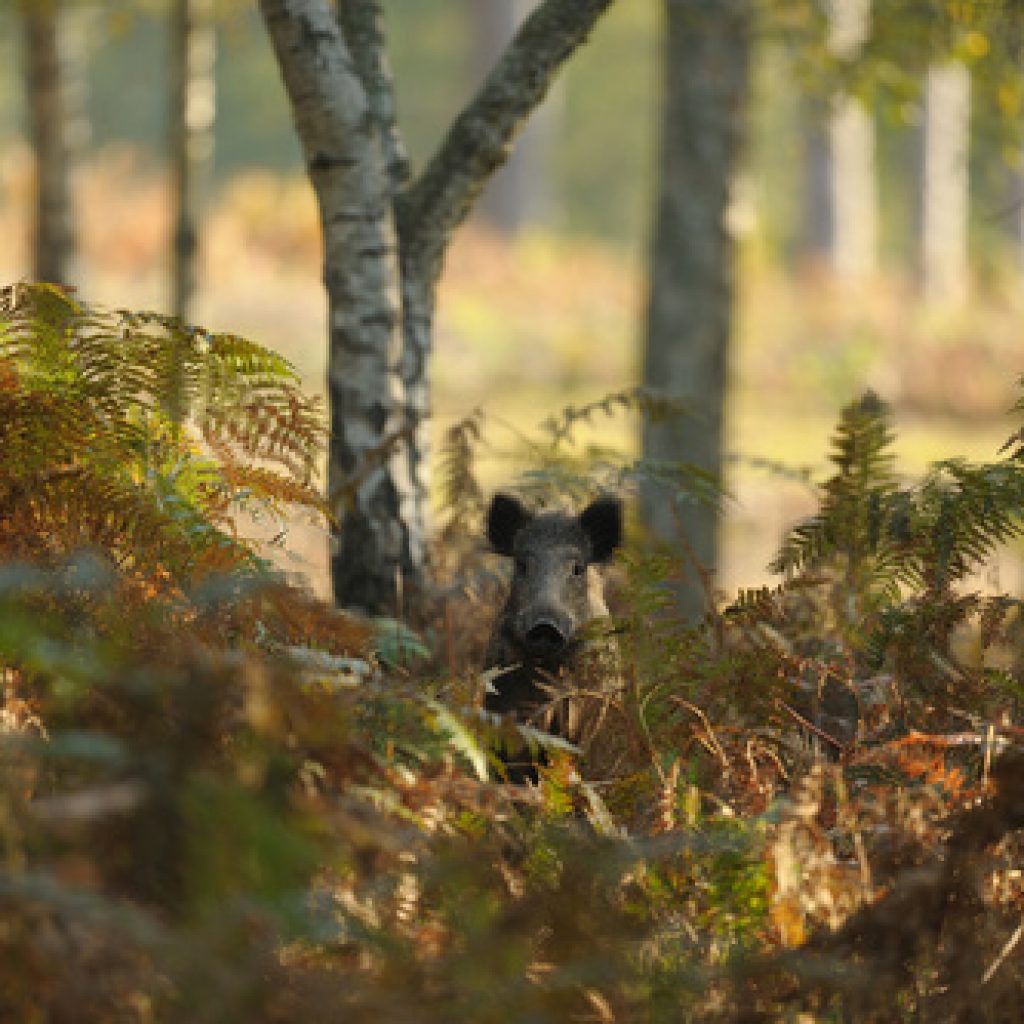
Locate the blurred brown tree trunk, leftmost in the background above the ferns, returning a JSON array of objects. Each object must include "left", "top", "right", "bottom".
[{"left": 19, "top": 0, "right": 88, "bottom": 285}]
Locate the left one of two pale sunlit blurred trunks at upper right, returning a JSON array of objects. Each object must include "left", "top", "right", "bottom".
[{"left": 805, "top": 0, "right": 879, "bottom": 282}]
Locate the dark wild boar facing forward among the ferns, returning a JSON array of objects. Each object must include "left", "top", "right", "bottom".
[{"left": 484, "top": 494, "right": 623, "bottom": 781}]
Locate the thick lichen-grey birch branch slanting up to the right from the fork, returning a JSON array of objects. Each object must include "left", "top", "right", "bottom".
[{"left": 397, "top": 0, "right": 614, "bottom": 280}]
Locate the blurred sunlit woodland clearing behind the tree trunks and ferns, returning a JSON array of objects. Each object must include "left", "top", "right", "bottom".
[{"left": 6, "top": 0, "right": 1024, "bottom": 593}]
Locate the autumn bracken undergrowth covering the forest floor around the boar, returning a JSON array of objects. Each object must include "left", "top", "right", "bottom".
[{"left": 0, "top": 286, "right": 1024, "bottom": 1024}]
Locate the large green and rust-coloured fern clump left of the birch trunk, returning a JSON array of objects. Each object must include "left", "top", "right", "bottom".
[{"left": 0, "top": 285, "right": 325, "bottom": 582}]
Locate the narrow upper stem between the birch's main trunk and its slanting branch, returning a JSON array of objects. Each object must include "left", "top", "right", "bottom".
[{"left": 337, "top": 0, "right": 411, "bottom": 190}]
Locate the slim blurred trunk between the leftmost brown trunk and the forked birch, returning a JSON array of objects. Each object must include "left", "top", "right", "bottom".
[{"left": 168, "top": 0, "right": 216, "bottom": 321}]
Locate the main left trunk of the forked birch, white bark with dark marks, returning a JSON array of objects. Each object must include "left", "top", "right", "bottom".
[{"left": 260, "top": 0, "right": 413, "bottom": 610}]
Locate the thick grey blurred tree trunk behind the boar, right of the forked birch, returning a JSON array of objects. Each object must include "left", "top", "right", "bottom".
[{"left": 641, "top": 0, "right": 752, "bottom": 617}]
